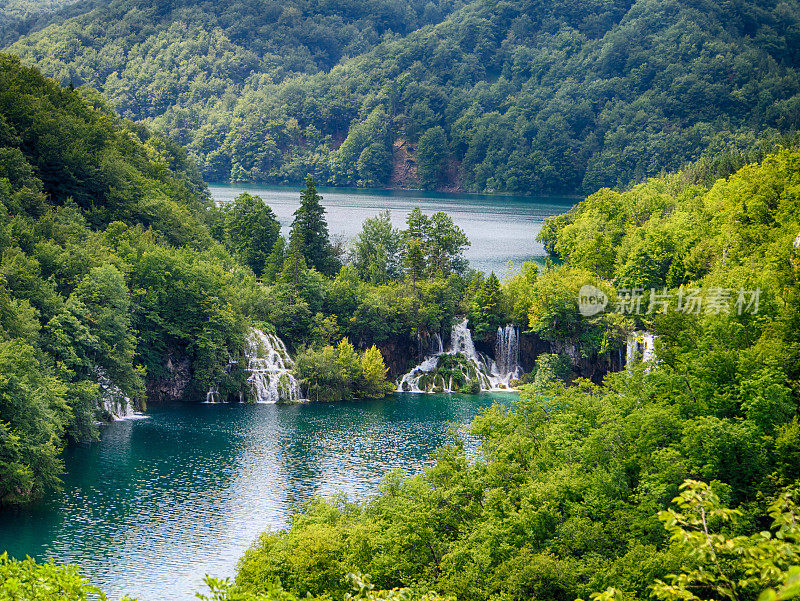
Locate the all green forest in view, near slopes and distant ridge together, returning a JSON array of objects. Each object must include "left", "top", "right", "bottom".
[{"left": 0, "top": 0, "right": 800, "bottom": 601}]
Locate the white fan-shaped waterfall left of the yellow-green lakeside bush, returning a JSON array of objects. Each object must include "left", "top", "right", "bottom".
[{"left": 242, "top": 328, "right": 300, "bottom": 403}]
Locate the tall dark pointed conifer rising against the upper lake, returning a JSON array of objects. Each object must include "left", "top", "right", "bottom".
[{"left": 290, "top": 177, "right": 339, "bottom": 276}]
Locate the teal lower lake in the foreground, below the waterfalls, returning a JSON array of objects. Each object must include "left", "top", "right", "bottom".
[{"left": 0, "top": 393, "right": 516, "bottom": 601}]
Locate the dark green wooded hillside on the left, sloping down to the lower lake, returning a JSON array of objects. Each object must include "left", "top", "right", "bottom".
[{"left": 0, "top": 56, "right": 263, "bottom": 504}]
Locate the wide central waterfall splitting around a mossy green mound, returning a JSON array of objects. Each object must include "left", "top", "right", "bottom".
[{"left": 397, "top": 319, "right": 522, "bottom": 392}]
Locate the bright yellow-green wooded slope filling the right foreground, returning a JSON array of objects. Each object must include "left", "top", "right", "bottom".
[{"left": 208, "top": 149, "right": 800, "bottom": 601}]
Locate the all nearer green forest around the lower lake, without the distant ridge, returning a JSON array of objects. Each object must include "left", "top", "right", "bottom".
[{"left": 0, "top": 57, "right": 800, "bottom": 601}]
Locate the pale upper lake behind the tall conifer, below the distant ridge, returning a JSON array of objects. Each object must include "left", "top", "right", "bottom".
[{"left": 209, "top": 184, "right": 580, "bottom": 276}]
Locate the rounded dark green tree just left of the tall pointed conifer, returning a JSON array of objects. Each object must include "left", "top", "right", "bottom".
[{"left": 225, "top": 192, "right": 281, "bottom": 276}]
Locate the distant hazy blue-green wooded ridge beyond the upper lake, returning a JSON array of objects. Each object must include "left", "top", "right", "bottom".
[{"left": 6, "top": 0, "right": 800, "bottom": 192}]
